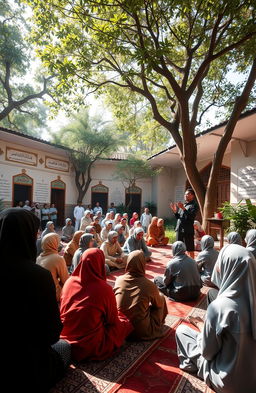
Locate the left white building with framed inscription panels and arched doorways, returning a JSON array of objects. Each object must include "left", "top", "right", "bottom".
[{"left": 0, "top": 127, "right": 152, "bottom": 225}]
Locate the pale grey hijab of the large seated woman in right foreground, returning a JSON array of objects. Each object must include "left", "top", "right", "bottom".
[{"left": 218, "top": 244, "right": 256, "bottom": 340}]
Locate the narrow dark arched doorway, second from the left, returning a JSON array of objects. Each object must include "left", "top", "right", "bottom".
[{"left": 51, "top": 176, "right": 66, "bottom": 226}]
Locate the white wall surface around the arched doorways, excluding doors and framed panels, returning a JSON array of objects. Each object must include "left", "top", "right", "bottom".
[{"left": 0, "top": 135, "right": 152, "bottom": 215}]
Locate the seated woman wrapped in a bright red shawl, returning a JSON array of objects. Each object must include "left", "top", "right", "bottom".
[{"left": 60, "top": 248, "right": 133, "bottom": 361}]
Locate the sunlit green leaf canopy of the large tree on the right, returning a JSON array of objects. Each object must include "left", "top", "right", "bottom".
[{"left": 26, "top": 0, "right": 256, "bottom": 119}]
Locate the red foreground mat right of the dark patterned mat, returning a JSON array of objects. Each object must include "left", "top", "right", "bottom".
[{"left": 115, "top": 287, "right": 214, "bottom": 393}]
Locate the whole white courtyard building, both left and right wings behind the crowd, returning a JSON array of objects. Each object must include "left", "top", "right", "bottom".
[{"left": 0, "top": 109, "right": 256, "bottom": 225}]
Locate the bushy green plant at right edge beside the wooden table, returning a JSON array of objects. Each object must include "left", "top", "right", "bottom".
[{"left": 219, "top": 200, "right": 256, "bottom": 238}]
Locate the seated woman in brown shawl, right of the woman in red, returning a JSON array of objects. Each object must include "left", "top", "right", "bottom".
[{"left": 114, "top": 251, "right": 168, "bottom": 340}]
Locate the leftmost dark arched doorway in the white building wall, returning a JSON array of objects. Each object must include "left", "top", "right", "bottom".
[{"left": 12, "top": 170, "right": 33, "bottom": 206}]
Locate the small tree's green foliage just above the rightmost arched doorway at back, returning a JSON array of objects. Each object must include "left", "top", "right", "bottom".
[{"left": 115, "top": 155, "right": 161, "bottom": 188}]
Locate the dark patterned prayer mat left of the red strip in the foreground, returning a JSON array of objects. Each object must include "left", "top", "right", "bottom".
[{"left": 50, "top": 315, "right": 178, "bottom": 393}]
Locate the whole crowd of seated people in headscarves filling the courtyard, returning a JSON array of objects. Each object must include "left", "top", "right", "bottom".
[{"left": 4, "top": 202, "right": 256, "bottom": 393}]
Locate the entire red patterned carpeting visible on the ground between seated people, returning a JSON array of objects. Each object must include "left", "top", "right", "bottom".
[{"left": 51, "top": 246, "right": 214, "bottom": 393}]
